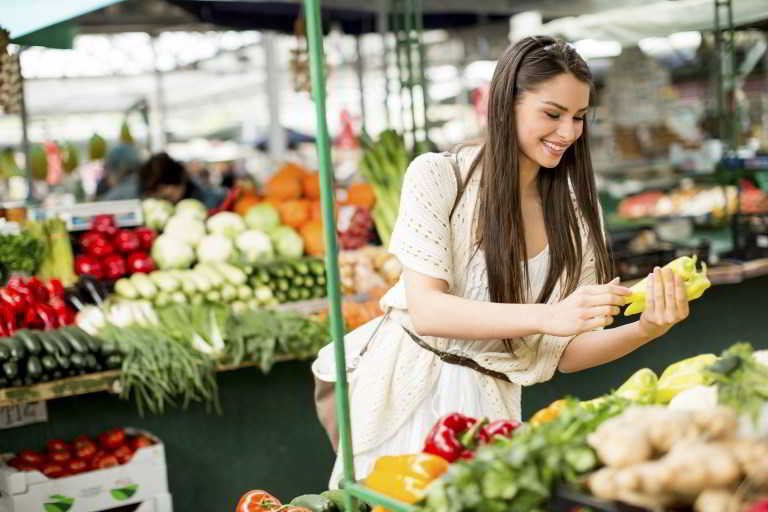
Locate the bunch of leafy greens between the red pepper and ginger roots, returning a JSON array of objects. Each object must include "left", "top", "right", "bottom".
[{"left": 421, "top": 396, "right": 631, "bottom": 512}]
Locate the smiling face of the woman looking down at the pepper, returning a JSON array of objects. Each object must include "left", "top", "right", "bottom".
[{"left": 515, "top": 73, "right": 589, "bottom": 168}]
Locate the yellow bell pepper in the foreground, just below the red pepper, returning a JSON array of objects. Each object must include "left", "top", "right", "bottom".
[{"left": 365, "top": 453, "right": 449, "bottom": 503}]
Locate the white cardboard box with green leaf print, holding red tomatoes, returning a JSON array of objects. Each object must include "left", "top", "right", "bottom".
[{"left": 0, "top": 428, "right": 172, "bottom": 512}]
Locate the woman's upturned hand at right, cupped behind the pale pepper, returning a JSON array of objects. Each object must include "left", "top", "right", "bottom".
[{"left": 638, "top": 267, "right": 689, "bottom": 339}]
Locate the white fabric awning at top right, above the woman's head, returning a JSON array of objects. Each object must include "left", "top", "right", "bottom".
[{"left": 540, "top": 0, "right": 768, "bottom": 45}]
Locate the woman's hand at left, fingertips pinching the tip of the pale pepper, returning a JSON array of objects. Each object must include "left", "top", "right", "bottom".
[{"left": 541, "top": 277, "right": 632, "bottom": 336}]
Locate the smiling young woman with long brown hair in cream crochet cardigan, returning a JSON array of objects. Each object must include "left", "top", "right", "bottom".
[{"left": 313, "top": 37, "right": 688, "bottom": 486}]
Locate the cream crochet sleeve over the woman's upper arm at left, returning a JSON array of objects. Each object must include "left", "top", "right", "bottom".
[{"left": 389, "top": 153, "right": 457, "bottom": 288}]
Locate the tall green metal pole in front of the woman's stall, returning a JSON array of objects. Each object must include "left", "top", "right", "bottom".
[{"left": 304, "top": 0, "right": 355, "bottom": 512}]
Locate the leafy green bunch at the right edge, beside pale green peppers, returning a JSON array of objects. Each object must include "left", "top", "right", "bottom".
[{"left": 704, "top": 343, "right": 768, "bottom": 419}]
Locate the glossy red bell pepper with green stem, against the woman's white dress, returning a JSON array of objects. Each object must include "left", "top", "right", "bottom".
[{"left": 422, "top": 413, "right": 488, "bottom": 462}]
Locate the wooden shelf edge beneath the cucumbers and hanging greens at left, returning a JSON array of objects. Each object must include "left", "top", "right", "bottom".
[{"left": 0, "top": 354, "right": 316, "bottom": 407}]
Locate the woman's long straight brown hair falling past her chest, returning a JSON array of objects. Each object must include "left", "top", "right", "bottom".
[{"left": 462, "top": 36, "right": 612, "bottom": 336}]
